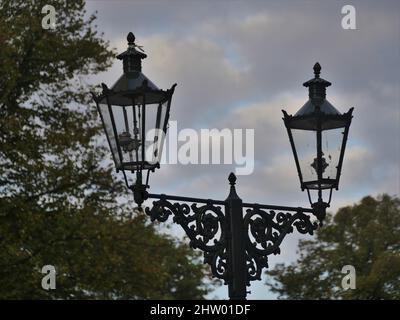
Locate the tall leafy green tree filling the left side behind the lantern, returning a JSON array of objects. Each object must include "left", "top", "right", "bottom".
[{"left": 0, "top": 0, "right": 216, "bottom": 299}]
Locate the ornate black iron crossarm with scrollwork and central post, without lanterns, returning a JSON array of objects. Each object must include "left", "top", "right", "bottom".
[{"left": 141, "top": 173, "right": 326, "bottom": 299}]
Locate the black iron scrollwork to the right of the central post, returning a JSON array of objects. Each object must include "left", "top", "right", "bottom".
[{"left": 244, "top": 206, "right": 318, "bottom": 285}]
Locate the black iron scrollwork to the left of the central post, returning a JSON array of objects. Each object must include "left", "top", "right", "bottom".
[{"left": 145, "top": 196, "right": 227, "bottom": 283}]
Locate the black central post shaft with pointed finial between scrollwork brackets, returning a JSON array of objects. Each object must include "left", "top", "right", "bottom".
[{"left": 225, "top": 175, "right": 247, "bottom": 300}]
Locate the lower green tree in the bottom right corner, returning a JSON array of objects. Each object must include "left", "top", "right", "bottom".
[{"left": 267, "top": 194, "right": 400, "bottom": 299}]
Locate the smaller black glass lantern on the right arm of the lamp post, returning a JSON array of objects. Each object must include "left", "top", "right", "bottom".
[{"left": 282, "top": 62, "right": 353, "bottom": 212}]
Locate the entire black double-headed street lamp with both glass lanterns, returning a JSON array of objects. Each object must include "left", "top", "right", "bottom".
[{"left": 93, "top": 33, "right": 353, "bottom": 299}]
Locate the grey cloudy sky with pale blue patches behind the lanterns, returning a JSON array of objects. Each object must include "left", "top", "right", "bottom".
[{"left": 87, "top": 0, "right": 400, "bottom": 299}]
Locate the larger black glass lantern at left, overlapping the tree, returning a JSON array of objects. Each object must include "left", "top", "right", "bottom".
[{"left": 93, "top": 32, "right": 176, "bottom": 202}]
